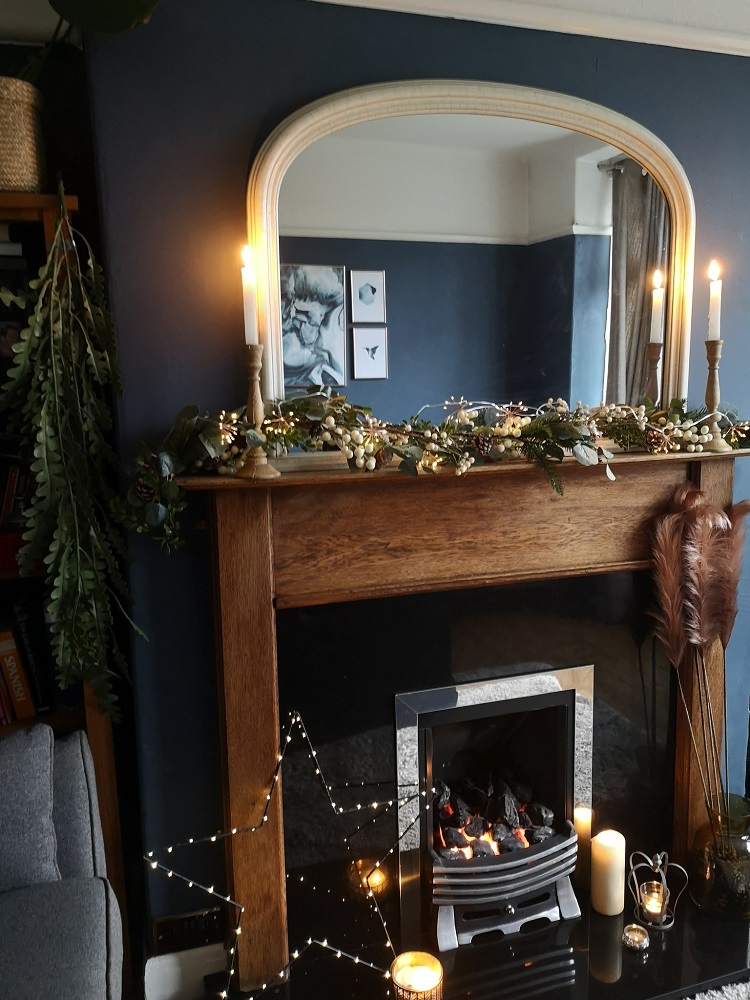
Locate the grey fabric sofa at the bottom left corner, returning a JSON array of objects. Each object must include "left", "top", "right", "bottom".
[{"left": 0, "top": 725, "right": 122, "bottom": 1000}]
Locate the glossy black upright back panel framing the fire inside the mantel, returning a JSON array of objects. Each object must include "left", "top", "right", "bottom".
[{"left": 277, "top": 573, "right": 676, "bottom": 974}]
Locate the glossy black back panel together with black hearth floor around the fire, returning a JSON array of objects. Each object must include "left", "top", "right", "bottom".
[{"left": 201, "top": 573, "right": 750, "bottom": 1000}]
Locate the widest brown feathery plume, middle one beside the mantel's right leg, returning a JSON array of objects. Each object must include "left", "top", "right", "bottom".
[{"left": 682, "top": 504, "right": 731, "bottom": 653}]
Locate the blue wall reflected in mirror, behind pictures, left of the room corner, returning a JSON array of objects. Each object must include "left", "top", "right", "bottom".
[{"left": 279, "top": 236, "right": 526, "bottom": 421}]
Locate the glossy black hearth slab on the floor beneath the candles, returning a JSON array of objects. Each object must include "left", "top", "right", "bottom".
[{"left": 207, "top": 884, "right": 750, "bottom": 1000}]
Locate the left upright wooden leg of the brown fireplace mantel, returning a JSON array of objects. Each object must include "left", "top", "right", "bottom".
[{"left": 213, "top": 488, "right": 288, "bottom": 991}]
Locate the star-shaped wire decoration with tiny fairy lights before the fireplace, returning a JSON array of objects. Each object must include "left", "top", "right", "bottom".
[{"left": 143, "top": 711, "right": 435, "bottom": 1000}]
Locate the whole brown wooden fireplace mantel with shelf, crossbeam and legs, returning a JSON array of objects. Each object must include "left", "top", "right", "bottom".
[{"left": 187, "top": 452, "right": 748, "bottom": 990}]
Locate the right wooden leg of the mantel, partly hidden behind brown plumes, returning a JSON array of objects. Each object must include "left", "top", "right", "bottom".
[{"left": 673, "top": 458, "right": 734, "bottom": 864}]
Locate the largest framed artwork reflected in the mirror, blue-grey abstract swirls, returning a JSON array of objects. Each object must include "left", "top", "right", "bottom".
[{"left": 280, "top": 264, "right": 346, "bottom": 389}]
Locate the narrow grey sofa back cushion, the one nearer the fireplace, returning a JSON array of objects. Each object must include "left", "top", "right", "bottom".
[{"left": 52, "top": 732, "right": 107, "bottom": 878}]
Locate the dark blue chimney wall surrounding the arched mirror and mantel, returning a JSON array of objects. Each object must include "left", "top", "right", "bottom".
[{"left": 89, "top": 0, "right": 750, "bottom": 910}]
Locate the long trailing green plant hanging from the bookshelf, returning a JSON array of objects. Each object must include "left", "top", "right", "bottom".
[{"left": 0, "top": 186, "right": 139, "bottom": 716}]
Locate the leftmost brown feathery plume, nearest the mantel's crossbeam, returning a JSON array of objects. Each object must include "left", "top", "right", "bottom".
[{"left": 653, "top": 513, "right": 687, "bottom": 667}]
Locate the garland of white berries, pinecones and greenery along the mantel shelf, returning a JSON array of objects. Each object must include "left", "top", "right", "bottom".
[{"left": 114, "top": 387, "right": 750, "bottom": 549}]
